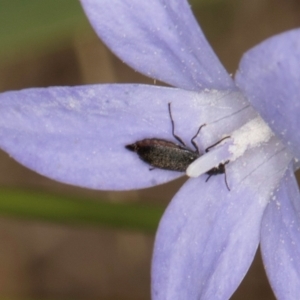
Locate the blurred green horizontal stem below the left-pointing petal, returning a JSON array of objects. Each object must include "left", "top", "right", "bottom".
[{"left": 0, "top": 188, "right": 163, "bottom": 233}]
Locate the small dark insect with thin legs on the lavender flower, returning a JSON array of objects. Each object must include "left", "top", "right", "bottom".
[{"left": 125, "top": 103, "right": 230, "bottom": 191}]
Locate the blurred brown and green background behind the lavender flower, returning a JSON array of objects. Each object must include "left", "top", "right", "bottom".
[{"left": 0, "top": 0, "right": 300, "bottom": 300}]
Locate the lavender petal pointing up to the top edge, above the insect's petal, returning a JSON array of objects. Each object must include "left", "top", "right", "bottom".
[{"left": 81, "top": 0, "right": 234, "bottom": 90}]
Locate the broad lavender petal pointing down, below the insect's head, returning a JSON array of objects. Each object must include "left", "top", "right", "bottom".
[{"left": 152, "top": 138, "right": 291, "bottom": 300}]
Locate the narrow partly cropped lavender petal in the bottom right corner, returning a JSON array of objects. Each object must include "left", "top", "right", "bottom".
[{"left": 261, "top": 168, "right": 300, "bottom": 299}]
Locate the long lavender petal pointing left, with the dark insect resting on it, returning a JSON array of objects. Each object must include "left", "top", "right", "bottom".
[{"left": 0, "top": 85, "right": 247, "bottom": 190}]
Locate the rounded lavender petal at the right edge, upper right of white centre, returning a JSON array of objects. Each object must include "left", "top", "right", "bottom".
[{"left": 236, "top": 29, "right": 300, "bottom": 158}]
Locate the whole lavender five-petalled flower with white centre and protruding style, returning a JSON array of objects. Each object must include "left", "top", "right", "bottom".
[{"left": 0, "top": 0, "right": 300, "bottom": 300}]
